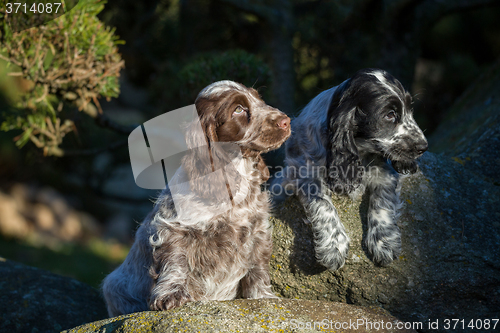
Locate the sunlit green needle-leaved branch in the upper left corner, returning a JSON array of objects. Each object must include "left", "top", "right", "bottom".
[{"left": 0, "top": 0, "right": 124, "bottom": 156}]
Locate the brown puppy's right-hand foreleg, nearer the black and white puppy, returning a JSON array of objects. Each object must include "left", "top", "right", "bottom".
[{"left": 240, "top": 228, "right": 277, "bottom": 299}]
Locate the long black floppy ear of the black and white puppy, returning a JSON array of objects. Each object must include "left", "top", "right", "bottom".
[{"left": 327, "top": 82, "right": 363, "bottom": 193}]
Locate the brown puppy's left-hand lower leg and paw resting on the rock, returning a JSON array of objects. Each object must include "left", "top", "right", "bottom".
[{"left": 148, "top": 253, "right": 193, "bottom": 311}]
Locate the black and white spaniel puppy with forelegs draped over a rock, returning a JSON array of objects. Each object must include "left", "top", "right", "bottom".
[{"left": 271, "top": 69, "right": 427, "bottom": 270}]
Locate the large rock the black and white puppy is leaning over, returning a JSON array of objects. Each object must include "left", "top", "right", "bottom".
[{"left": 270, "top": 153, "right": 500, "bottom": 330}]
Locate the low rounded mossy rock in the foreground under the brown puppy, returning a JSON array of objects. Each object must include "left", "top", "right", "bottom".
[{"left": 64, "top": 299, "right": 415, "bottom": 333}]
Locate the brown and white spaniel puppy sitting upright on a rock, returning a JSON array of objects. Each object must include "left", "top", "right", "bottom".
[{"left": 103, "top": 81, "right": 290, "bottom": 316}]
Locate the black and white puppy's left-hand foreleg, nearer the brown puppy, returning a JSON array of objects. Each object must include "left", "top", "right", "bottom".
[{"left": 297, "top": 178, "right": 349, "bottom": 271}]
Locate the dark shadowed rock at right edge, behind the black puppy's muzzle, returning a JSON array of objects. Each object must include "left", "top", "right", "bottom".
[{"left": 429, "top": 61, "right": 500, "bottom": 186}]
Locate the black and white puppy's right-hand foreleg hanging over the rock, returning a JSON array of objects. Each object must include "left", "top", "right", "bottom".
[{"left": 365, "top": 168, "right": 401, "bottom": 266}]
